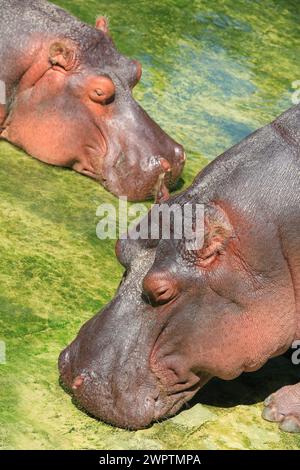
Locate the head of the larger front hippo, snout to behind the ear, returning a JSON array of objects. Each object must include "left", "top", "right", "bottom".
[{"left": 59, "top": 167, "right": 295, "bottom": 429}]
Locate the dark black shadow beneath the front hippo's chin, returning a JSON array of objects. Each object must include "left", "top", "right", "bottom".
[{"left": 189, "top": 350, "right": 300, "bottom": 408}]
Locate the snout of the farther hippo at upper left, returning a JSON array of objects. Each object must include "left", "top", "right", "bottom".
[{"left": 101, "top": 99, "right": 186, "bottom": 201}]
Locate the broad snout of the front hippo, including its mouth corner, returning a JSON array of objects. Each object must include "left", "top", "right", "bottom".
[{"left": 59, "top": 302, "right": 210, "bottom": 429}]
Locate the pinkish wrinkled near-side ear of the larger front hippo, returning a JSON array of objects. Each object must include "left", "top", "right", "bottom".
[{"left": 196, "top": 206, "right": 235, "bottom": 268}]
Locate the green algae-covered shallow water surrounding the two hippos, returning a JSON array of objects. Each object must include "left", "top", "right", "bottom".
[{"left": 0, "top": 0, "right": 300, "bottom": 449}]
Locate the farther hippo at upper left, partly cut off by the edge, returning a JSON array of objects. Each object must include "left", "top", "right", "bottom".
[{"left": 0, "top": 0, "right": 185, "bottom": 200}]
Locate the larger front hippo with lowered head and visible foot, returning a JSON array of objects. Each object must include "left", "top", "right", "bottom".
[{"left": 59, "top": 105, "right": 300, "bottom": 432}]
